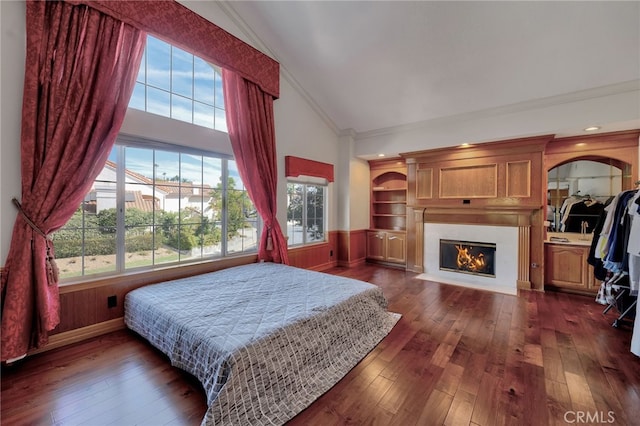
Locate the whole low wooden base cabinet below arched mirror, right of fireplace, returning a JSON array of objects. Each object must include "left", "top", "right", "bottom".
[{"left": 545, "top": 243, "right": 600, "bottom": 294}]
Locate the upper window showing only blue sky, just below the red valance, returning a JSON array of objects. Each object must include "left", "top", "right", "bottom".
[{"left": 129, "top": 36, "right": 227, "bottom": 132}]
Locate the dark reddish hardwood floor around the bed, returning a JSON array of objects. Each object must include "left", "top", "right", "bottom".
[{"left": 0, "top": 265, "right": 640, "bottom": 426}]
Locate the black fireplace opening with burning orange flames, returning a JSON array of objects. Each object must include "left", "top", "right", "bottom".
[{"left": 440, "top": 240, "right": 496, "bottom": 277}]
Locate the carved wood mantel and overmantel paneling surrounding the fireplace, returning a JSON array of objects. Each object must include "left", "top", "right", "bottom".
[{"left": 401, "top": 135, "right": 553, "bottom": 290}]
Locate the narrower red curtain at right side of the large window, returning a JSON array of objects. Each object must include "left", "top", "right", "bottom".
[{"left": 222, "top": 69, "right": 289, "bottom": 264}]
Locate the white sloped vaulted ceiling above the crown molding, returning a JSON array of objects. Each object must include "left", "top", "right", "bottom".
[{"left": 225, "top": 1, "right": 640, "bottom": 145}]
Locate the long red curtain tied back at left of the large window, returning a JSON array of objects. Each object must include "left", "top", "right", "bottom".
[{"left": 1, "top": 1, "right": 145, "bottom": 361}]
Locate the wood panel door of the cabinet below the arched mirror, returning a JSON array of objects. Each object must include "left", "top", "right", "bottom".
[{"left": 546, "top": 245, "right": 590, "bottom": 290}]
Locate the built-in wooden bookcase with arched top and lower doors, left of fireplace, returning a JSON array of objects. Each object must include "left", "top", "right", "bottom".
[{"left": 367, "top": 160, "right": 407, "bottom": 265}]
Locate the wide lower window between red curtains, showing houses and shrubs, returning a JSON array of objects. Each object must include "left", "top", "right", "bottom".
[{"left": 53, "top": 141, "right": 259, "bottom": 278}]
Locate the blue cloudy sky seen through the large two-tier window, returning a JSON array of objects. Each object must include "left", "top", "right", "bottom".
[{"left": 109, "top": 36, "right": 241, "bottom": 188}]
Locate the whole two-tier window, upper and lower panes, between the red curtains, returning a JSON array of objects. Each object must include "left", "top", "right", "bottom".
[{"left": 53, "top": 36, "right": 260, "bottom": 279}]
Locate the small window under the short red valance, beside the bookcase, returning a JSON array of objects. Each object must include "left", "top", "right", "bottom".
[{"left": 287, "top": 182, "right": 327, "bottom": 246}]
